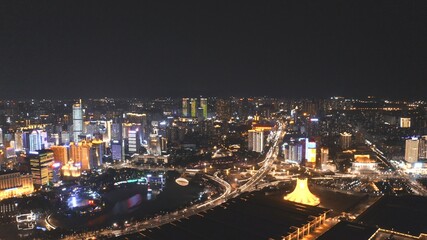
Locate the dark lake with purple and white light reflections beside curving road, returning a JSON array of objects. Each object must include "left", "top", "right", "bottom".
[{"left": 51, "top": 172, "right": 204, "bottom": 229}]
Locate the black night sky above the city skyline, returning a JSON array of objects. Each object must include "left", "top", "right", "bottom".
[{"left": 0, "top": 0, "right": 427, "bottom": 99}]
